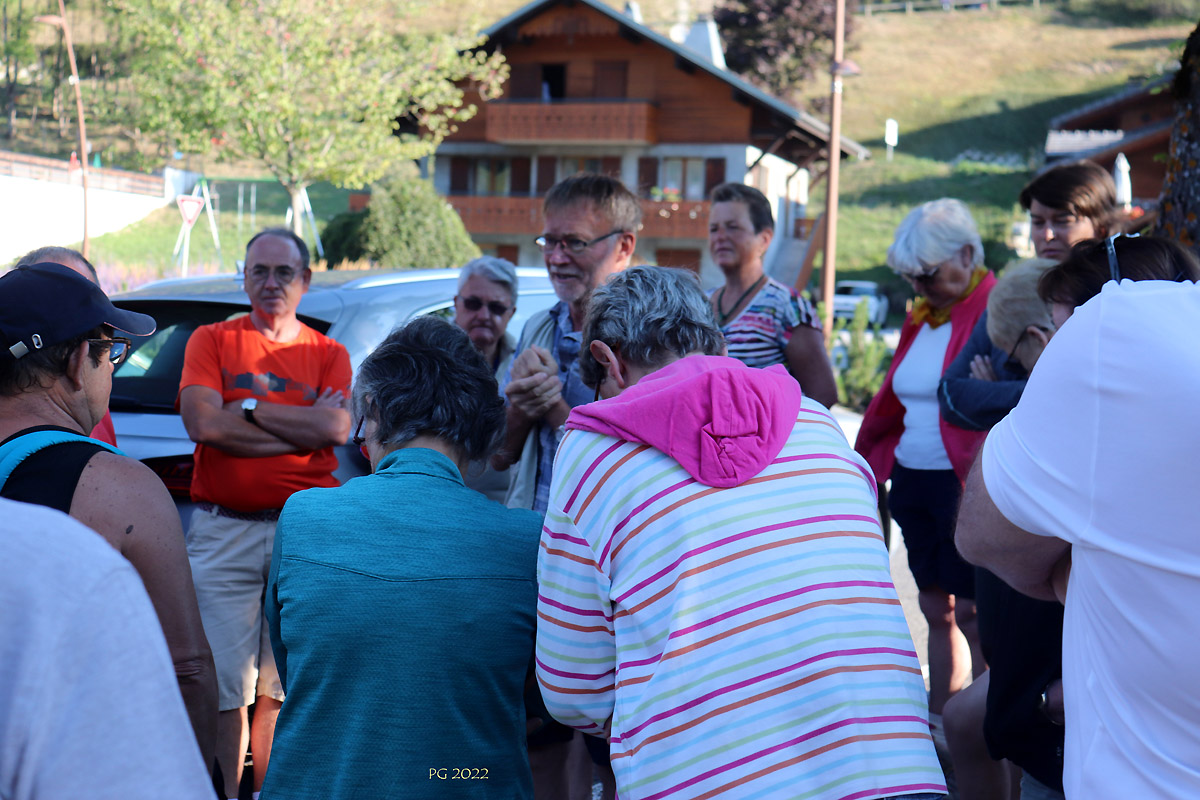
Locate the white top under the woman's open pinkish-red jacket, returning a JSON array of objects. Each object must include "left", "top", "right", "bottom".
[{"left": 892, "top": 323, "right": 954, "bottom": 469}]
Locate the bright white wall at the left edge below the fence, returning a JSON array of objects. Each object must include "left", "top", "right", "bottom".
[{"left": 0, "top": 176, "right": 170, "bottom": 264}]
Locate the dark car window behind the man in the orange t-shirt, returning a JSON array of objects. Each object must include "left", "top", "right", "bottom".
[{"left": 109, "top": 301, "right": 329, "bottom": 411}]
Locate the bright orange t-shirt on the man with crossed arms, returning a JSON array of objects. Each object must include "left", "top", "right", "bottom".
[{"left": 176, "top": 315, "right": 350, "bottom": 511}]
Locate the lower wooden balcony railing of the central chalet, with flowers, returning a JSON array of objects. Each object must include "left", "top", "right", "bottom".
[{"left": 446, "top": 196, "right": 708, "bottom": 239}]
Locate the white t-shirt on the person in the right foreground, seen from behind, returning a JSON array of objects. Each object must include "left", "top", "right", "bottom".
[{"left": 983, "top": 281, "right": 1200, "bottom": 799}]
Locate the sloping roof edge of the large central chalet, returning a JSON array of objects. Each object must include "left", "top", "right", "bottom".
[{"left": 484, "top": 0, "right": 871, "bottom": 158}]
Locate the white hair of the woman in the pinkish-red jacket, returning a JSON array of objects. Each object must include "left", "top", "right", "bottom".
[{"left": 888, "top": 197, "right": 983, "bottom": 275}]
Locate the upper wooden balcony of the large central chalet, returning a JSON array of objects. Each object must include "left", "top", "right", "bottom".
[{"left": 485, "top": 100, "right": 659, "bottom": 144}]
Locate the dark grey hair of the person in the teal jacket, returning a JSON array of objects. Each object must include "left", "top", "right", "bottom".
[{"left": 353, "top": 315, "right": 504, "bottom": 461}]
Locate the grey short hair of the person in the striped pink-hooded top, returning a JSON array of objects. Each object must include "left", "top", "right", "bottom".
[{"left": 580, "top": 266, "right": 725, "bottom": 387}]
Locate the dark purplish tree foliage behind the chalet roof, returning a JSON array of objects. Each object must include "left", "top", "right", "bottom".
[{"left": 713, "top": 0, "right": 853, "bottom": 102}]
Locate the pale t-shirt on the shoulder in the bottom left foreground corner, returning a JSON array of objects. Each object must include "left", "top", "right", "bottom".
[{"left": 0, "top": 500, "right": 212, "bottom": 800}]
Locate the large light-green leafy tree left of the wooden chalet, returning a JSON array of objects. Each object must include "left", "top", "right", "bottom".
[{"left": 113, "top": 0, "right": 508, "bottom": 235}]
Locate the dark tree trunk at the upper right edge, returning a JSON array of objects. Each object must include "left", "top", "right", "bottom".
[{"left": 1154, "top": 25, "right": 1200, "bottom": 255}]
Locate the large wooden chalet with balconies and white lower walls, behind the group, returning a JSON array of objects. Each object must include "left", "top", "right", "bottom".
[{"left": 433, "top": 0, "right": 869, "bottom": 285}]
